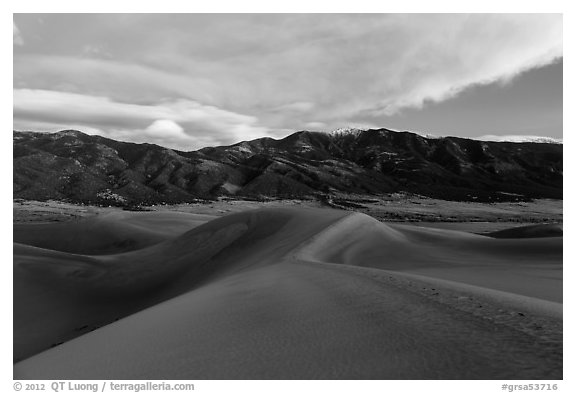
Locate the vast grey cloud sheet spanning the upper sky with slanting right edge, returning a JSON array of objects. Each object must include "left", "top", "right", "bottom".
[{"left": 14, "top": 14, "right": 563, "bottom": 139}]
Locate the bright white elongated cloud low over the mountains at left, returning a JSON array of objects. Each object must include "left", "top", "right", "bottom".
[{"left": 14, "top": 89, "right": 268, "bottom": 149}]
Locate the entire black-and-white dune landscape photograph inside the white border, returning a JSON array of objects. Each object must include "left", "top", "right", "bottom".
[{"left": 5, "top": 5, "right": 569, "bottom": 386}]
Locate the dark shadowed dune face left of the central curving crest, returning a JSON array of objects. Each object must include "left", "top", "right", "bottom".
[{"left": 14, "top": 209, "right": 343, "bottom": 359}]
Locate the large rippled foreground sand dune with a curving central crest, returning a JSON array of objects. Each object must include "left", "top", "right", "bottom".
[{"left": 14, "top": 208, "right": 562, "bottom": 379}]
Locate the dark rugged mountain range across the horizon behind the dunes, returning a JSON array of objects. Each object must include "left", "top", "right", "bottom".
[{"left": 13, "top": 129, "right": 563, "bottom": 205}]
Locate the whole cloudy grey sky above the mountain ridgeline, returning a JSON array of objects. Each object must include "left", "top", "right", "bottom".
[{"left": 13, "top": 14, "right": 563, "bottom": 150}]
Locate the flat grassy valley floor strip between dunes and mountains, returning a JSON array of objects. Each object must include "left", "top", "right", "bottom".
[{"left": 13, "top": 194, "right": 563, "bottom": 233}]
